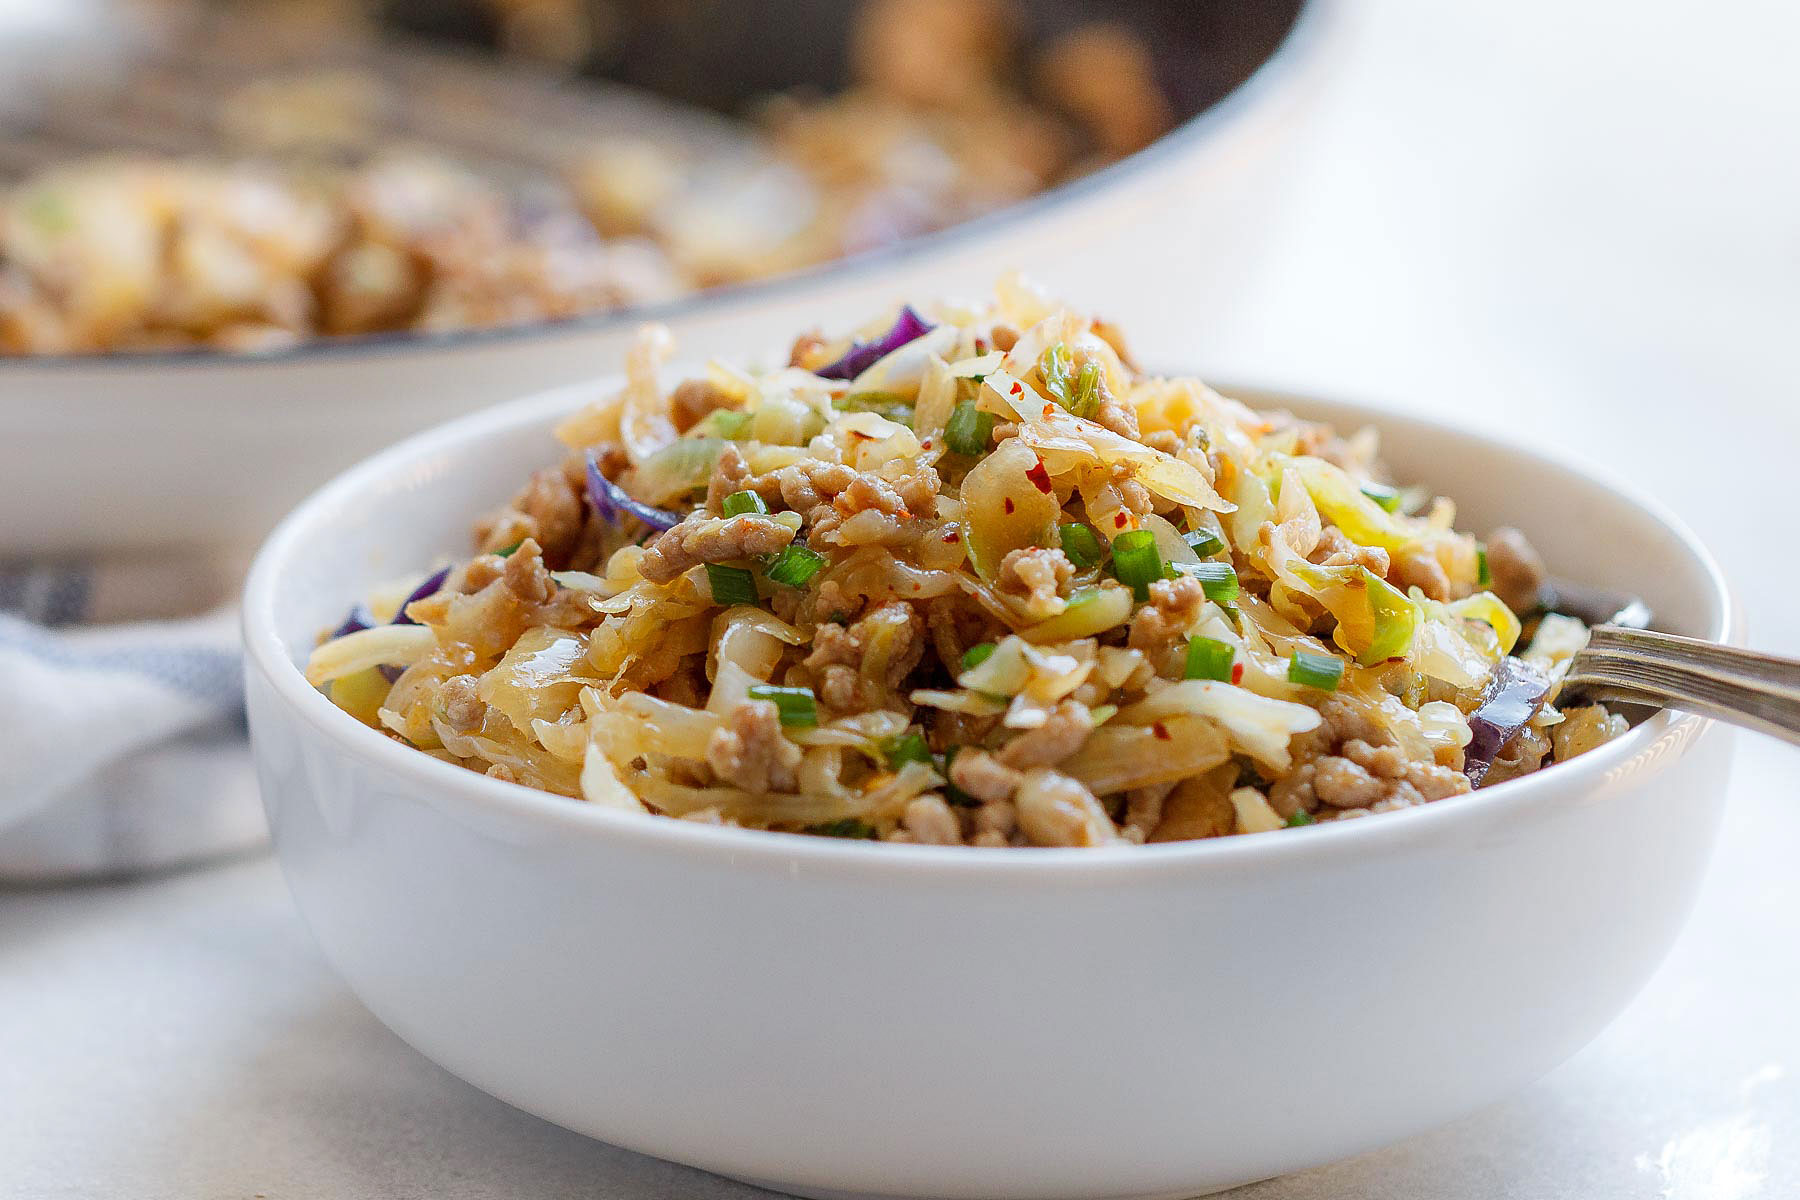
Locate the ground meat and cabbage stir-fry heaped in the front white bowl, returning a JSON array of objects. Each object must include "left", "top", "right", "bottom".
[{"left": 308, "top": 281, "right": 1625, "bottom": 846}]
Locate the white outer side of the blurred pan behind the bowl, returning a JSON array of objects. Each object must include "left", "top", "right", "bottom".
[{"left": 0, "top": 0, "right": 1346, "bottom": 558}]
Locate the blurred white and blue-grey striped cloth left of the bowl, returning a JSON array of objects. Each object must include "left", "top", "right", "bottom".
[{"left": 0, "top": 560, "right": 259, "bottom": 878}]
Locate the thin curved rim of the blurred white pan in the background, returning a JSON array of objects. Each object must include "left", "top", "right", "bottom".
[{"left": 0, "top": 0, "right": 1345, "bottom": 376}]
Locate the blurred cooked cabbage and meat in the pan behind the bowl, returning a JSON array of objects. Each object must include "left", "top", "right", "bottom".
[{"left": 0, "top": 0, "right": 1174, "bottom": 354}]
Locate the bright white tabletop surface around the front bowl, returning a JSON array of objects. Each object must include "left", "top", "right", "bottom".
[{"left": 0, "top": 0, "right": 1800, "bottom": 1200}]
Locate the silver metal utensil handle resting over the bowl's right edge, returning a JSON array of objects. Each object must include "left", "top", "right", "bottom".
[{"left": 1562, "top": 624, "right": 1800, "bottom": 745}]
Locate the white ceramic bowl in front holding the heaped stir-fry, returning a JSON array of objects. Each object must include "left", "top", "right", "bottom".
[{"left": 245, "top": 379, "right": 1735, "bottom": 1200}]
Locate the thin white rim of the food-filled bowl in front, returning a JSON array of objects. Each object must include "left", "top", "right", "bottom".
[{"left": 241, "top": 376, "right": 1741, "bottom": 883}]
